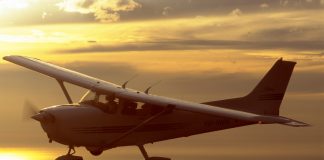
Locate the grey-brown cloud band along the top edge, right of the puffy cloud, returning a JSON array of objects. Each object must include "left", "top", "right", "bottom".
[{"left": 121, "top": 0, "right": 324, "bottom": 20}]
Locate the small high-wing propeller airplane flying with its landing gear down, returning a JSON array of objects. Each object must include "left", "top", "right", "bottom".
[{"left": 3, "top": 55, "right": 309, "bottom": 160}]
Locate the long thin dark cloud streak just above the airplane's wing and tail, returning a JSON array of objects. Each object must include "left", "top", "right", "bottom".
[{"left": 58, "top": 40, "right": 324, "bottom": 53}]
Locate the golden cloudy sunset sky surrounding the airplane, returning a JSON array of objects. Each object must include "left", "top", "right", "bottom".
[{"left": 0, "top": 0, "right": 324, "bottom": 160}]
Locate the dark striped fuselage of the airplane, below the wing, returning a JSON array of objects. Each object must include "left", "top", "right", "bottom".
[{"left": 41, "top": 104, "right": 252, "bottom": 149}]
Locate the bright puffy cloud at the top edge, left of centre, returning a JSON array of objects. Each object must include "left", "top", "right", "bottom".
[{"left": 57, "top": 0, "right": 141, "bottom": 22}]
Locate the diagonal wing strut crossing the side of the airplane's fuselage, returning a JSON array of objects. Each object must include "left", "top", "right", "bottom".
[{"left": 107, "top": 105, "right": 175, "bottom": 147}]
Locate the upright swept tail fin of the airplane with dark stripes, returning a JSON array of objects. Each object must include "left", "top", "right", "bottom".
[{"left": 204, "top": 59, "right": 296, "bottom": 115}]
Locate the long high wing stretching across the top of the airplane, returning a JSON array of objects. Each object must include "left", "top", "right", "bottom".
[{"left": 3, "top": 56, "right": 307, "bottom": 127}]
